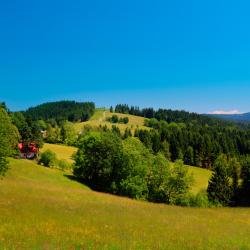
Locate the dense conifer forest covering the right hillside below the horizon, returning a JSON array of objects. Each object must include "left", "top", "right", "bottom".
[{"left": 115, "top": 104, "right": 250, "bottom": 168}]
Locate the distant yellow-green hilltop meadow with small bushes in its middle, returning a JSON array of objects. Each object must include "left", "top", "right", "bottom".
[{"left": 74, "top": 109, "right": 149, "bottom": 133}]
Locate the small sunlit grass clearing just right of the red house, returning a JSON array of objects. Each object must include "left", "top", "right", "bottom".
[{"left": 41, "top": 143, "right": 77, "bottom": 163}]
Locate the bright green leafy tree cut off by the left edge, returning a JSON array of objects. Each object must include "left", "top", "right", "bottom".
[{"left": 0, "top": 108, "right": 20, "bottom": 175}]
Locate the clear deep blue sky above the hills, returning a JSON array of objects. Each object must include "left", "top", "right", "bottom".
[{"left": 0, "top": 0, "right": 250, "bottom": 113}]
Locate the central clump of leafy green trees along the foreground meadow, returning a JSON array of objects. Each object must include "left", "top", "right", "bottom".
[{"left": 74, "top": 131, "right": 192, "bottom": 204}]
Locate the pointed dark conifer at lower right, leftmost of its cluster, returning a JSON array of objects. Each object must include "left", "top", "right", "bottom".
[{"left": 207, "top": 155, "right": 233, "bottom": 206}]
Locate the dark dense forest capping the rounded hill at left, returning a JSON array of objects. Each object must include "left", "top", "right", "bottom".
[{"left": 24, "top": 101, "right": 95, "bottom": 122}]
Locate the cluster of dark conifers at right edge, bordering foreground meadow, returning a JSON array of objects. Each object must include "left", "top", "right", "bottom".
[{"left": 207, "top": 155, "right": 250, "bottom": 206}]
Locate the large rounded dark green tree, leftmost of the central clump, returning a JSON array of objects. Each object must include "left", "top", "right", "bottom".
[{"left": 74, "top": 132, "right": 123, "bottom": 192}]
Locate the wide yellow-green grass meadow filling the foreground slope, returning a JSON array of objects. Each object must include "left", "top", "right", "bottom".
[{"left": 0, "top": 159, "right": 250, "bottom": 249}]
